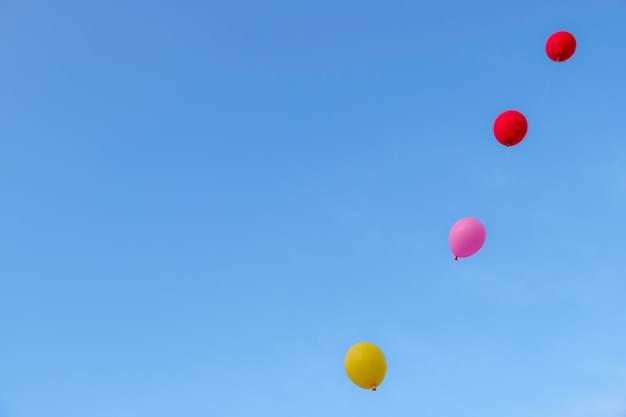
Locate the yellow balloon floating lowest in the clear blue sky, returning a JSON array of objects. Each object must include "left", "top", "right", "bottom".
[{"left": 343, "top": 342, "right": 387, "bottom": 391}]
